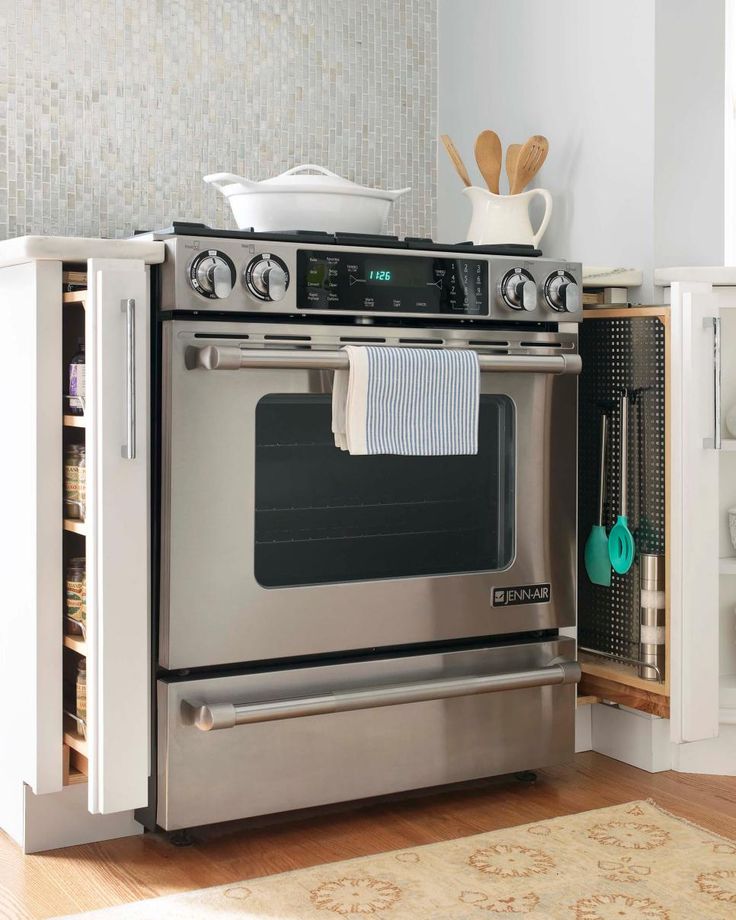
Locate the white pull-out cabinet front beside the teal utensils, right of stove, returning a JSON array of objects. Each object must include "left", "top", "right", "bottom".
[{"left": 670, "top": 284, "right": 720, "bottom": 741}]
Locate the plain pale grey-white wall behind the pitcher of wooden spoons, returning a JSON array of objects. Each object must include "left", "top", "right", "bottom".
[{"left": 438, "top": 0, "right": 725, "bottom": 301}]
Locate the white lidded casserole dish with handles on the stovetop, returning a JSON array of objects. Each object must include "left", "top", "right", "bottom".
[{"left": 204, "top": 163, "right": 411, "bottom": 233}]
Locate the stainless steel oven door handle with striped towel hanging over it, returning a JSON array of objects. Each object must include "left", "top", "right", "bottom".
[{"left": 185, "top": 345, "right": 582, "bottom": 374}]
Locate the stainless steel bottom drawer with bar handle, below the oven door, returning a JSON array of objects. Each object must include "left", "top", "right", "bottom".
[{"left": 157, "top": 638, "right": 579, "bottom": 830}]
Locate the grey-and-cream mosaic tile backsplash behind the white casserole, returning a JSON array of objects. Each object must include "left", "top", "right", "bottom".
[{"left": 0, "top": 0, "right": 437, "bottom": 238}]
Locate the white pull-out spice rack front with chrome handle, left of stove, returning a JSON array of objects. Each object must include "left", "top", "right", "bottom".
[{"left": 86, "top": 259, "right": 150, "bottom": 814}]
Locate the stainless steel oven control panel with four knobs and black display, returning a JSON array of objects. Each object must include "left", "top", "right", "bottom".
[{"left": 160, "top": 236, "right": 583, "bottom": 323}]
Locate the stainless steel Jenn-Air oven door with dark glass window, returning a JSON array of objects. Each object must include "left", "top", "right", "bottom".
[{"left": 160, "top": 321, "right": 579, "bottom": 669}]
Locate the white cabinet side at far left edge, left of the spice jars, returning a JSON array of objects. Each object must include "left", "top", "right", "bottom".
[{"left": 0, "top": 261, "right": 63, "bottom": 796}]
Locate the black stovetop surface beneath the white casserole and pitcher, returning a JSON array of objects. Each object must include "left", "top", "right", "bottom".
[{"left": 136, "top": 221, "right": 542, "bottom": 258}]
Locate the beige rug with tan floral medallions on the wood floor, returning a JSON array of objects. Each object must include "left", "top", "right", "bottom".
[{"left": 56, "top": 802, "right": 736, "bottom": 920}]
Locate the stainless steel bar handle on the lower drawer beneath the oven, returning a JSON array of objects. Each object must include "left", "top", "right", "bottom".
[{"left": 181, "top": 660, "right": 581, "bottom": 732}]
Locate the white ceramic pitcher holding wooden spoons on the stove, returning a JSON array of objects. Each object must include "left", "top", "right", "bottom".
[{"left": 463, "top": 185, "right": 552, "bottom": 248}]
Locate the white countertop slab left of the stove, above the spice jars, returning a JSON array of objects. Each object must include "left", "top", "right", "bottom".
[{"left": 0, "top": 236, "right": 164, "bottom": 267}]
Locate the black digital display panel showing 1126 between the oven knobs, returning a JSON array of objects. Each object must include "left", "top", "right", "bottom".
[{"left": 297, "top": 249, "right": 489, "bottom": 316}]
